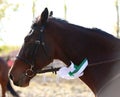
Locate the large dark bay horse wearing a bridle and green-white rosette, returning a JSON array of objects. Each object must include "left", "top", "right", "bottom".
[{"left": 10, "top": 8, "right": 120, "bottom": 97}]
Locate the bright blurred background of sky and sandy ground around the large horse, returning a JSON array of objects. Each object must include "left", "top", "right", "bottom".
[{"left": 0, "top": 0, "right": 120, "bottom": 97}]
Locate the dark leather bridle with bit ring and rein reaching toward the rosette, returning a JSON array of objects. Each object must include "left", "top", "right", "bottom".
[{"left": 16, "top": 25, "right": 59, "bottom": 78}]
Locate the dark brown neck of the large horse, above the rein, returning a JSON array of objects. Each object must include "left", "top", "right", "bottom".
[{"left": 52, "top": 25, "right": 120, "bottom": 64}]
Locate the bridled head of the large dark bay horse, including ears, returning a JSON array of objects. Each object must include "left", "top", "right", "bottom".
[{"left": 10, "top": 8, "right": 54, "bottom": 87}]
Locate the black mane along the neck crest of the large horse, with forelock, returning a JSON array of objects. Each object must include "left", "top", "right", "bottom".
[{"left": 32, "top": 12, "right": 117, "bottom": 39}]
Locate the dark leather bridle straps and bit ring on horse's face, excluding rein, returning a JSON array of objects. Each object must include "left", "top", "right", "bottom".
[{"left": 16, "top": 26, "right": 51, "bottom": 77}]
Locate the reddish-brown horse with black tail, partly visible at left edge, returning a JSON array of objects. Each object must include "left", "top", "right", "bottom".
[{"left": 0, "top": 57, "right": 19, "bottom": 97}]
